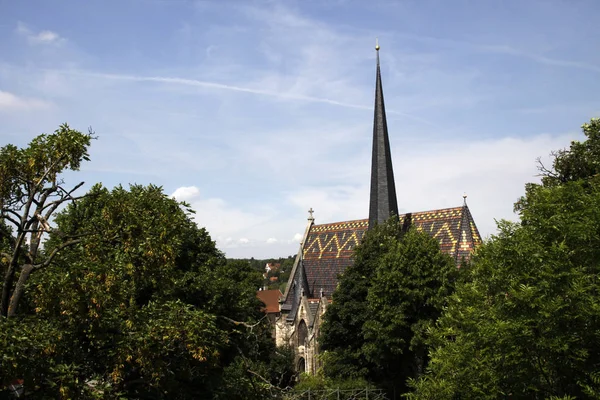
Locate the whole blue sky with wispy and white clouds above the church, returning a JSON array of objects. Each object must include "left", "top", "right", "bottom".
[{"left": 0, "top": 0, "right": 600, "bottom": 258}]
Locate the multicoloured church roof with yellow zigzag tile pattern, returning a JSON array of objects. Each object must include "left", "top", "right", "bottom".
[{"left": 282, "top": 204, "right": 481, "bottom": 318}]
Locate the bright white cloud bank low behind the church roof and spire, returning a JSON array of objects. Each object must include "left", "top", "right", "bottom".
[{"left": 173, "top": 134, "right": 579, "bottom": 258}]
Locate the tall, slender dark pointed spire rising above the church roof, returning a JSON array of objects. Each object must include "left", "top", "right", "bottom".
[{"left": 369, "top": 42, "right": 398, "bottom": 229}]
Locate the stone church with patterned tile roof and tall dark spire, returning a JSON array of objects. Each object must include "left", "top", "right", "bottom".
[{"left": 275, "top": 45, "right": 481, "bottom": 374}]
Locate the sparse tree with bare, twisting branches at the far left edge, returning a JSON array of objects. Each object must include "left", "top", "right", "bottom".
[{"left": 0, "top": 124, "right": 92, "bottom": 317}]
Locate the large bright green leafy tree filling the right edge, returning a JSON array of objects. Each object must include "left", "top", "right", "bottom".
[{"left": 410, "top": 119, "right": 600, "bottom": 399}]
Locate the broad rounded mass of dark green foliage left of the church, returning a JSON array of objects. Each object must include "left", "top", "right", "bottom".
[{"left": 0, "top": 185, "right": 292, "bottom": 399}]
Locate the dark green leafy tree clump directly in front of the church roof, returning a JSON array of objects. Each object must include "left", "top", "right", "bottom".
[{"left": 321, "top": 219, "right": 457, "bottom": 398}]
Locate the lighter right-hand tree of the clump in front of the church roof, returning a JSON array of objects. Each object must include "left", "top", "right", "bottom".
[{"left": 363, "top": 229, "right": 458, "bottom": 398}]
